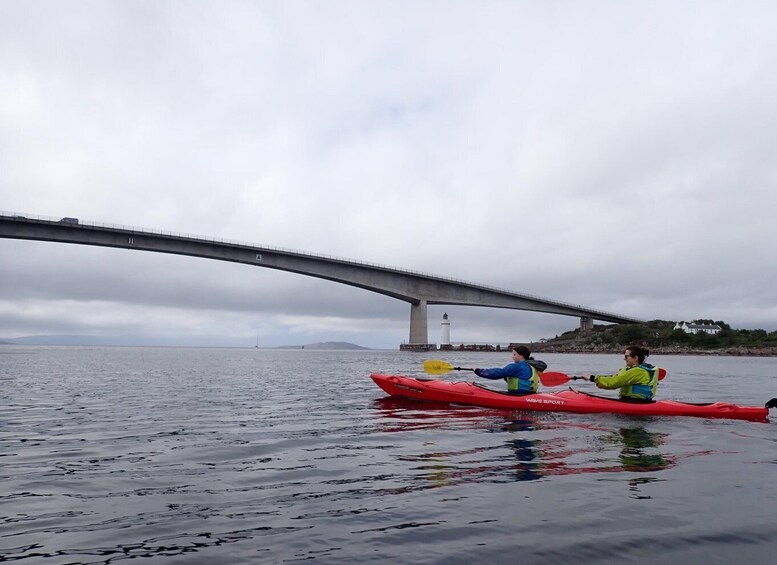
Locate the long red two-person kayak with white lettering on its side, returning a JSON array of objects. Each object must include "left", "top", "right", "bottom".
[{"left": 370, "top": 373, "right": 777, "bottom": 421}]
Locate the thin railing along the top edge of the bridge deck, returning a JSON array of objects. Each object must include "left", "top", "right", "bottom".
[{"left": 0, "top": 210, "right": 622, "bottom": 318}]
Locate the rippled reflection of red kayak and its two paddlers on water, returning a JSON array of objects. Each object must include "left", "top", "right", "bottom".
[{"left": 374, "top": 397, "right": 675, "bottom": 488}]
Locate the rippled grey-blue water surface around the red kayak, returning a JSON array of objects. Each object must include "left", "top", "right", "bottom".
[{"left": 0, "top": 346, "right": 777, "bottom": 565}]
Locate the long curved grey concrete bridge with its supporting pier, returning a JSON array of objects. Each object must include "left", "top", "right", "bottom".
[{"left": 0, "top": 212, "right": 642, "bottom": 350}]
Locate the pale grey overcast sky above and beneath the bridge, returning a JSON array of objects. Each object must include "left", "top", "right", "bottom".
[{"left": 0, "top": 0, "right": 777, "bottom": 349}]
